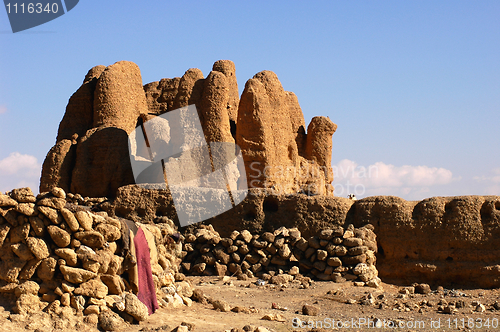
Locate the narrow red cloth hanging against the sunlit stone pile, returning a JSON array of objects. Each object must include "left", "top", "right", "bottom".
[{"left": 134, "top": 227, "right": 159, "bottom": 315}]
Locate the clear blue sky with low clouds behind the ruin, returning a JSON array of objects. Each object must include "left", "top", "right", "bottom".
[{"left": 0, "top": 0, "right": 500, "bottom": 199}]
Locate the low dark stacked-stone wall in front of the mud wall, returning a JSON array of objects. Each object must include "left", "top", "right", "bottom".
[{"left": 181, "top": 225, "right": 379, "bottom": 286}]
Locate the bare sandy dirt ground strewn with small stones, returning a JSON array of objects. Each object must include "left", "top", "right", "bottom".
[{"left": 0, "top": 277, "right": 500, "bottom": 332}]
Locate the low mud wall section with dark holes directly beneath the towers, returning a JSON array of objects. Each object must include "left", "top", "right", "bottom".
[{"left": 110, "top": 185, "right": 353, "bottom": 237}]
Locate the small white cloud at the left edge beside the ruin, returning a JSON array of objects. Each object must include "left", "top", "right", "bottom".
[{"left": 0, "top": 152, "right": 42, "bottom": 192}]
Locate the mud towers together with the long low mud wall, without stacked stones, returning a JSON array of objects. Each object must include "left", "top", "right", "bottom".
[{"left": 36, "top": 60, "right": 500, "bottom": 287}]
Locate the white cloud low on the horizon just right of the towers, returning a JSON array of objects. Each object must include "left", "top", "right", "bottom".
[{"left": 332, "top": 159, "right": 460, "bottom": 200}]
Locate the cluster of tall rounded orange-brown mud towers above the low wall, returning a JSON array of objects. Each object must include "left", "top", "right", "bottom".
[{"left": 40, "top": 60, "right": 337, "bottom": 197}]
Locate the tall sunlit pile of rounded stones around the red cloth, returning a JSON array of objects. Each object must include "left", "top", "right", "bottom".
[{"left": 0, "top": 188, "right": 192, "bottom": 328}]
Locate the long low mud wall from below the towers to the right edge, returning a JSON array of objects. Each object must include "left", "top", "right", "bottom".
[{"left": 99, "top": 186, "right": 500, "bottom": 287}]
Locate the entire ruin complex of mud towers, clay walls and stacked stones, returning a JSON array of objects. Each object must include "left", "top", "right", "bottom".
[{"left": 0, "top": 60, "right": 500, "bottom": 330}]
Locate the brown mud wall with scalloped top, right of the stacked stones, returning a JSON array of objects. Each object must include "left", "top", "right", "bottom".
[{"left": 348, "top": 196, "right": 500, "bottom": 287}]
